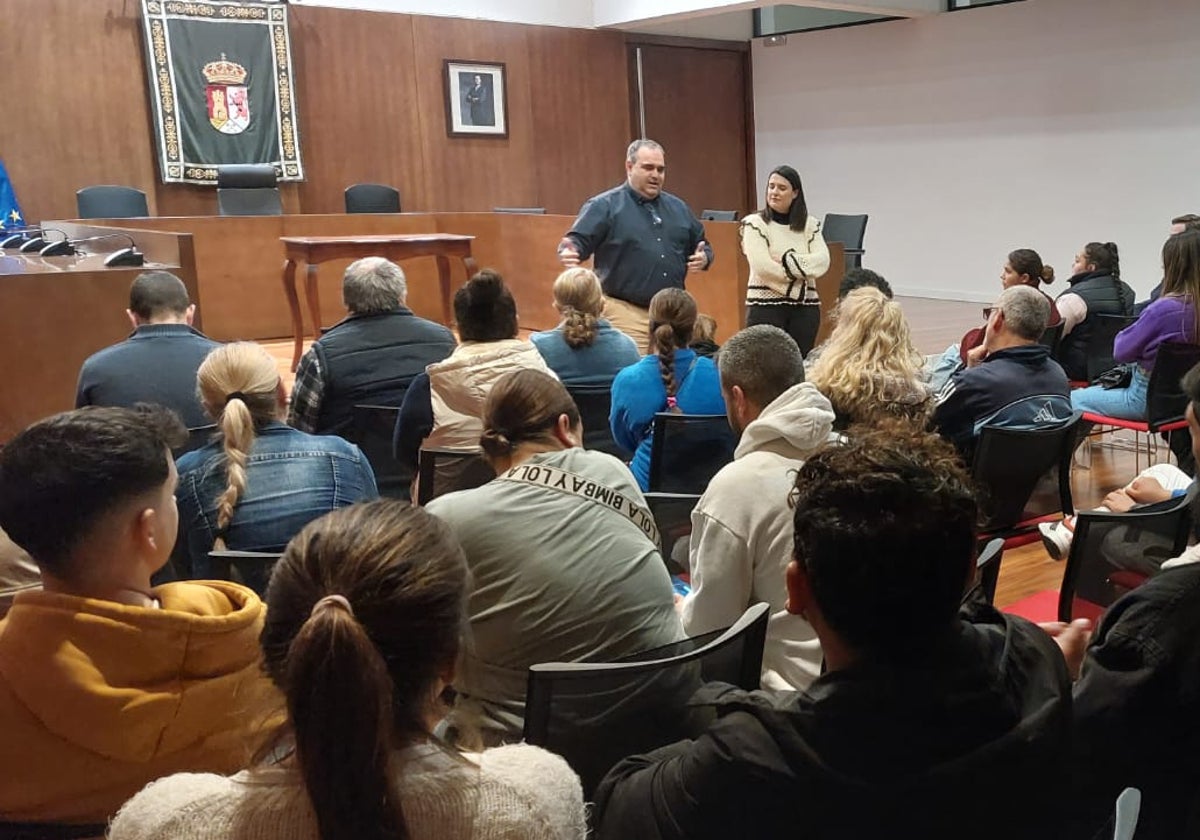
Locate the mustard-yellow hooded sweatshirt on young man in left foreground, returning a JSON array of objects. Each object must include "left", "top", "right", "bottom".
[{"left": 0, "top": 581, "right": 283, "bottom": 822}]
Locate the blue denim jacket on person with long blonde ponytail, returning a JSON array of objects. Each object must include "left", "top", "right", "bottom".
[{"left": 175, "top": 421, "right": 379, "bottom": 588}]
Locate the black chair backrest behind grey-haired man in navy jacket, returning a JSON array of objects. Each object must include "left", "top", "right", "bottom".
[{"left": 972, "top": 412, "right": 1080, "bottom": 533}]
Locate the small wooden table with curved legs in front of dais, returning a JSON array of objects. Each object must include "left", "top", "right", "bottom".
[{"left": 280, "top": 233, "right": 478, "bottom": 371}]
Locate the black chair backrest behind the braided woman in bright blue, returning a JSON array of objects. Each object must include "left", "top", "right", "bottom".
[{"left": 649, "top": 412, "right": 738, "bottom": 493}]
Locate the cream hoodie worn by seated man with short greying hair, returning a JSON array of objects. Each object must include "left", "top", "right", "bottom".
[{"left": 683, "top": 383, "right": 834, "bottom": 690}]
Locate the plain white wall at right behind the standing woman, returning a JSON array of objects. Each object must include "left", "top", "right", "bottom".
[{"left": 752, "top": 0, "right": 1200, "bottom": 301}]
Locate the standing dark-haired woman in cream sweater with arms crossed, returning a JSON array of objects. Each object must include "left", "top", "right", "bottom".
[{"left": 738, "top": 166, "right": 829, "bottom": 355}]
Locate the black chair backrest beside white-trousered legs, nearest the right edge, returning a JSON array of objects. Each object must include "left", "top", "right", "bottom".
[{"left": 1058, "top": 486, "right": 1196, "bottom": 622}]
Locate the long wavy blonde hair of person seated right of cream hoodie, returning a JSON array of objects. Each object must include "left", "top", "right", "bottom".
[{"left": 808, "top": 288, "right": 929, "bottom": 430}]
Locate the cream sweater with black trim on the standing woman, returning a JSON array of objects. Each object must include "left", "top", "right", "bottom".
[{"left": 738, "top": 212, "right": 829, "bottom": 306}]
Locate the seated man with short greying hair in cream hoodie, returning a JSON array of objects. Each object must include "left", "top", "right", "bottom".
[{"left": 679, "top": 324, "right": 833, "bottom": 689}]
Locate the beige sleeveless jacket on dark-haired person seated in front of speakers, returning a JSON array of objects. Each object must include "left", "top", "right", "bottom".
[{"left": 422, "top": 338, "right": 557, "bottom": 451}]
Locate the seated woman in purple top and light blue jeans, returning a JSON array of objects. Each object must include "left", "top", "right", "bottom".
[{"left": 1070, "top": 230, "right": 1200, "bottom": 420}]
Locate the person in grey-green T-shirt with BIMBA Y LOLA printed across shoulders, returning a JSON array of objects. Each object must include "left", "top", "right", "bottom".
[{"left": 427, "top": 367, "right": 683, "bottom": 743}]
